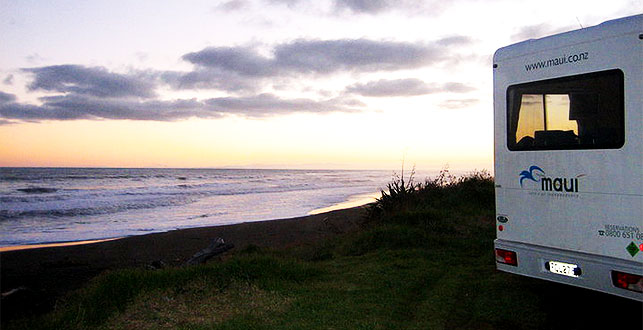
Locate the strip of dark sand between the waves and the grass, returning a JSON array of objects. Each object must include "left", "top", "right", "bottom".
[{"left": 0, "top": 207, "right": 365, "bottom": 323}]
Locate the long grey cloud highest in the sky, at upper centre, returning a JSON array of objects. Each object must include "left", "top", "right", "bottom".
[{"left": 166, "top": 39, "right": 449, "bottom": 93}]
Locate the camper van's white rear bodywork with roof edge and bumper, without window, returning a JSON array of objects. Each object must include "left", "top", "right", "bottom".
[{"left": 494, "top": 15, "right": 643, "bottom": 301}]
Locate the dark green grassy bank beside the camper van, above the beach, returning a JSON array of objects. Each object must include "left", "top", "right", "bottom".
[{"left": 10, "top": 171, "right": 641, "bottom": 329}]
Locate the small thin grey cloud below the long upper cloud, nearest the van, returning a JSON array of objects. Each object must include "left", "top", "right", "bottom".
[{"left": 346, "top": 78, "right": 475, "bottom": 97}]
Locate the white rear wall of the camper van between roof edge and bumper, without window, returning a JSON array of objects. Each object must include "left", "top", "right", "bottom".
[{"left": 494, "top": 20, "right": 643, "bottom": 261}]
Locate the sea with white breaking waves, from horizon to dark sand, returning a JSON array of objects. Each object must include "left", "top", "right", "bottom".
[{"left": 0, "top": 168, "right": 402, "bottom": 247}]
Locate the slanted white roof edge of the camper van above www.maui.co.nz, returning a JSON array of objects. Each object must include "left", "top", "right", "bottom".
[{"left": 493, "top": 14, "right": 643, "bottom": 63}]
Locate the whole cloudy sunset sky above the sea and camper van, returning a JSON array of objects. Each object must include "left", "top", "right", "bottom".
[{"left": 0, "top": 0, "right": 643, "bottom": 171}]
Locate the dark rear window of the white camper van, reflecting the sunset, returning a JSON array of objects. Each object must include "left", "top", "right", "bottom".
[{"left": 507, "top": 70, "right": 625, "bottom": 151}]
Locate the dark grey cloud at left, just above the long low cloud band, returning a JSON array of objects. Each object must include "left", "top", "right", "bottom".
[{"left": 23, "top": 65, "right": 155, "bottom": 97}]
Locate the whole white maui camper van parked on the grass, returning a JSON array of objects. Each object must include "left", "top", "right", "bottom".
[{"left": 493, "top": 15, "right": 643, "bottom": 301}]
